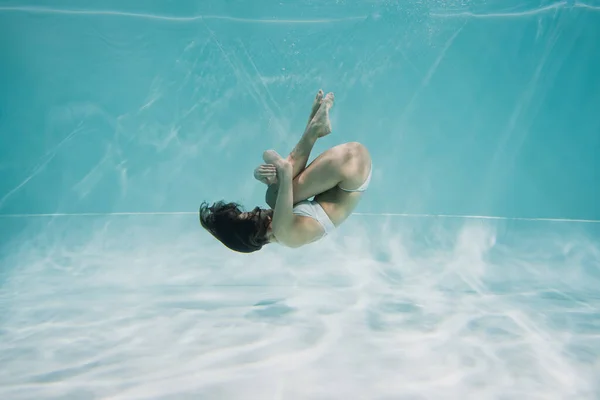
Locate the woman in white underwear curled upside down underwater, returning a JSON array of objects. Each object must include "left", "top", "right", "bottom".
[{"left": 200, "top": 90, "right": 372, "bottom": 253}]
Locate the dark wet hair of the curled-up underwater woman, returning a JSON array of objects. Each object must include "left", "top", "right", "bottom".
[{"left": 199, "top": 201, "right": 273, "bottom": 253}]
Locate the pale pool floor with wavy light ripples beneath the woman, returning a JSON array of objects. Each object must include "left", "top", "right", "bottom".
[{"left": 0, "top": 217, "right": 600, "bottom": 399}]
